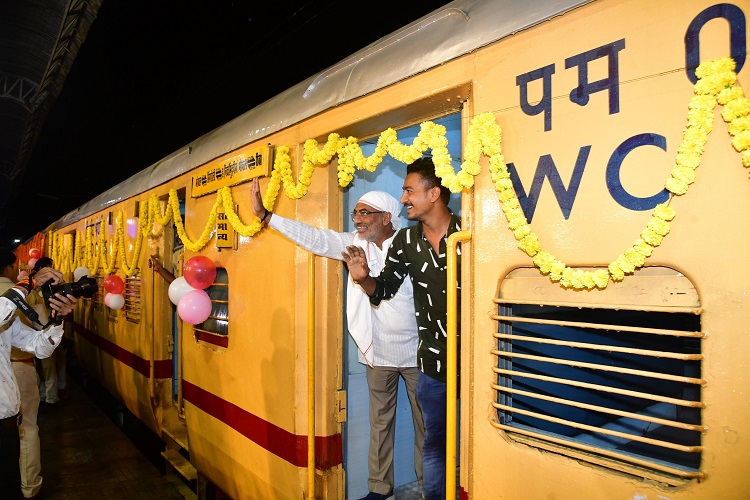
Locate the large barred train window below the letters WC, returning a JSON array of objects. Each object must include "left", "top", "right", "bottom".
[{"left": 492, "top": 268, "right": 705, "bottom": 485}]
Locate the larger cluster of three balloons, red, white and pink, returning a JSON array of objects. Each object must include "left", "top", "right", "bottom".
[{"left": 169, "top": 255, "right": 216, "bottom": 325}]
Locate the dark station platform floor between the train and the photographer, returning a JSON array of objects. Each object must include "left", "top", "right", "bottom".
[{"left": 33, "top": 358, "right": 197, "bottom": 500}]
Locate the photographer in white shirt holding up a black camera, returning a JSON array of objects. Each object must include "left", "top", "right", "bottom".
[{"left": 0, "top": 250, "right": 77, "bottom": 498}]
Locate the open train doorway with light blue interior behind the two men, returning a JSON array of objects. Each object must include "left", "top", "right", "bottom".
[{"left": 343, "top": 113, "right": 462, "bottom": 498}]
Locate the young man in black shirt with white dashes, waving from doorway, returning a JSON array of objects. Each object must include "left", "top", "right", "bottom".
[{"left": 344, "top": 158, "right": 461, "bottom": 500}]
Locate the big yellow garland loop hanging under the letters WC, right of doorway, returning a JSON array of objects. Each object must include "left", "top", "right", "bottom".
[{"left": 470, "top": 58, "right": 750, "bottom": 290}]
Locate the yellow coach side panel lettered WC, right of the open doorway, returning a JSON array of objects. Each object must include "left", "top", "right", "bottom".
[{"left": 462, "top": 1, "right": 750, "bottom": 498}]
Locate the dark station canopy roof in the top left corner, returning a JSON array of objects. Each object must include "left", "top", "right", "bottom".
[{"left": 0, "top": 0, "right": 102, "bottom": 228}]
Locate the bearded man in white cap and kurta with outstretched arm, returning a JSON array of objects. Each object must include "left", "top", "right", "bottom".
[{"left": 251, "top": 179, "right": 424, "bottom": 500}]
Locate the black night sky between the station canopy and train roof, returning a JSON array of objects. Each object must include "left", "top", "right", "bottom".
[{"left": 7, "top": 0, "right": 449, "bottom": 245}]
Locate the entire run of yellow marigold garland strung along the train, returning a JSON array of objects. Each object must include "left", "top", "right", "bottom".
[{"left": 49, "top": 58, "right": 750, "bottom": 290}]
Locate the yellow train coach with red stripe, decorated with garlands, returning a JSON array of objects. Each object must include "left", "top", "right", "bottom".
[{"left": 22, "top": 0, "right": 750, "bottom": 500}]
